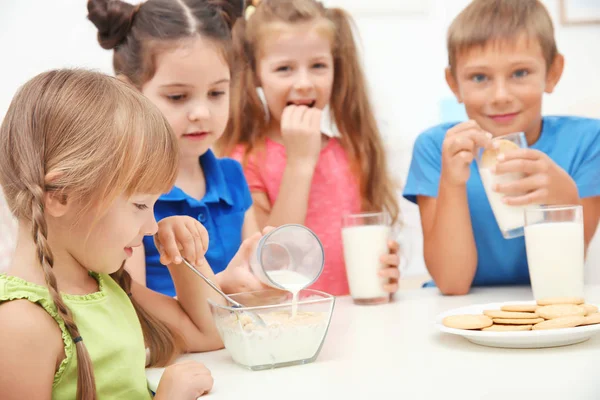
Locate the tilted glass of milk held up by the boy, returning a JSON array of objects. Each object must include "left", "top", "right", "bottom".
[{"left": 476, "top": 132, "right": 530, "bottom": 239}]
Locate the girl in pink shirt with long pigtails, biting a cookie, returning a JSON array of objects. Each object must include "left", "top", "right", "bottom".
[{"left": 218, "top": 0, "right": 400, "bottom": 295}]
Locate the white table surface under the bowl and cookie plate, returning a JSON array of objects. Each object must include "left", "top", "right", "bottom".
[{"left": 147, "top": 286, "right": 600, "bottom": 400}]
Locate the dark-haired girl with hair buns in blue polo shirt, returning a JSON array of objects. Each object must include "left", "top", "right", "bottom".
[{"left": 88, "top": 0, "right": 260, "bottom": 296}]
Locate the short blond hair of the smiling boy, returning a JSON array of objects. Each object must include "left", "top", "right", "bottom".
[{"left": 447, "top": 0, "right": 558, "bottom": 72}]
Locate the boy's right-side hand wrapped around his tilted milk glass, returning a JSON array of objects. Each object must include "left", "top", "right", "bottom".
[{"left": 492, "top": 149, "right": 579, "bottom": 206}]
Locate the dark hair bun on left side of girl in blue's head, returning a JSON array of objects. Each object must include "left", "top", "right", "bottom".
[{"left": 88, "top": 0, "right": 139, "bottom": 50}]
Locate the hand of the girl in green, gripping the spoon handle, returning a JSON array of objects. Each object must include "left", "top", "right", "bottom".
[{"left": 154, "top": 216, "right": 208, "bottom": 265}]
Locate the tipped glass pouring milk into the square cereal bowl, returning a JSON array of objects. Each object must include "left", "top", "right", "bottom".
[{"left": 250, "top": 224, "right": 325, "bottom": 296}]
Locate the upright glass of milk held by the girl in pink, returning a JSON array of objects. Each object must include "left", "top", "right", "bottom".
[{"left": 342, "top": 213, "right": 392, "bottom": 304}]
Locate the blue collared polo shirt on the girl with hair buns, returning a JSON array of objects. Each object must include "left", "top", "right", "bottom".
[{"left": 144, "top": 150, "right": 252, "bottom": 296}]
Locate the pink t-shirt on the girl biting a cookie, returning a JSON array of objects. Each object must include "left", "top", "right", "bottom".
[{"left": 232, "top": 139, "right": 361, "bottom": 296}]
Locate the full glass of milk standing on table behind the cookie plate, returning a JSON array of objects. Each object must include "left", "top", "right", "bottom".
[{"left": 525, "top": 205, "right": 585, "bottom": 300}]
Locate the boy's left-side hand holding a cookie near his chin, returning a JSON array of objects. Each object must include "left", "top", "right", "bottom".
[{"left": 441, "top": 121, "right": 492, "bottom": 186}]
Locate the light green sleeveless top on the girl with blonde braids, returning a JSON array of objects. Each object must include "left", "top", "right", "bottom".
[{"left": 0, "top": 274, "right": 152, "bottom": 400}]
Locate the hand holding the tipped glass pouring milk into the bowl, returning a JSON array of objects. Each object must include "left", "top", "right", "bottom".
[{"left": 216, "top": 227, "right": 273, "bottom": 293}]
